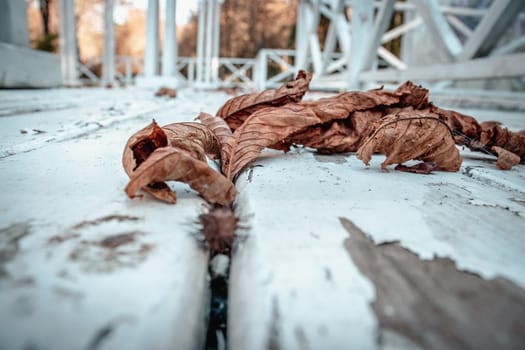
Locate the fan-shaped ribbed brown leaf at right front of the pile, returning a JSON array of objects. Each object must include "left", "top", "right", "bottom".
[{"left": 357, "top": 112, "right": 461, "bottom": 171}]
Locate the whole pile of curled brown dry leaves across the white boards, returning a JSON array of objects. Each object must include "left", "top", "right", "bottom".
[{"left": 123, "top": 71, "right": 525, "bottom": 219}]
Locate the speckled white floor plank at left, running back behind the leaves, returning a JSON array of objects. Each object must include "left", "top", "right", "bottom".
[{"left": 0, "top": 89, "right": 227, "bottom": 158}]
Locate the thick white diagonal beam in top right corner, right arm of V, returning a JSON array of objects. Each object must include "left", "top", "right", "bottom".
[{"left": 458, "top": 0, "right": 525, "bottom": 60}]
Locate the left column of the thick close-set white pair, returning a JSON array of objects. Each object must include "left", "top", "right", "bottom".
[{"left": 144, "top": 0, "right": 159, "bottom": 78}]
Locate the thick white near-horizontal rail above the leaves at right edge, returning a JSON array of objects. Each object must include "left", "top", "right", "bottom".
[{"left": 359, "top": 53, "right": 525, "bottom": 81}]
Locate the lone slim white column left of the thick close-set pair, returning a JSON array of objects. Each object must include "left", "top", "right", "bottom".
[{"left": 102, "top": 0, "right": 115, "bottom": 85}]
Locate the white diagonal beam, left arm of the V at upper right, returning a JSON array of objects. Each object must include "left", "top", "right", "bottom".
[{"left": 414, "top": 0, "right": 463, "bottom": 60}]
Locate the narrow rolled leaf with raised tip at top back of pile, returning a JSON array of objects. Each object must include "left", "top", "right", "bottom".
[{"left": 217, "top": 70, "right": 312, "bottom": 130}]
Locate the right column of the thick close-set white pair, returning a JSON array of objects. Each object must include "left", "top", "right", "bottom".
[{"left": 162, "top": 0, "right": 177, "bottom": 77}]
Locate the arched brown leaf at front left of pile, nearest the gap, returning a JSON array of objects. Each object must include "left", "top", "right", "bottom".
[{"left": 125, "top": 147, "right": 236, "bottom": 206}]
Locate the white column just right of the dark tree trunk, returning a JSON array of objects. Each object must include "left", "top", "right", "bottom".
[{"left": 59, "top": 0, "right": 79, "bottom": 85}]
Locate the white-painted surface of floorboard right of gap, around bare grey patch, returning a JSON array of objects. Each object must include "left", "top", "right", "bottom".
[{"left": 228, "top": 141, "right": 525, "bottom": 349}]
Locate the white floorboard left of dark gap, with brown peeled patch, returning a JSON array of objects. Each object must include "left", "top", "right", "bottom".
[{"left": 0, "top": 92, "right": 231, "bottom": 349}]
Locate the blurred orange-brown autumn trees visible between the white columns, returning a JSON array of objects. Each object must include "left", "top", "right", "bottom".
[{"left": 27, "top": 0, "right": 297, "bottom": 62}]
